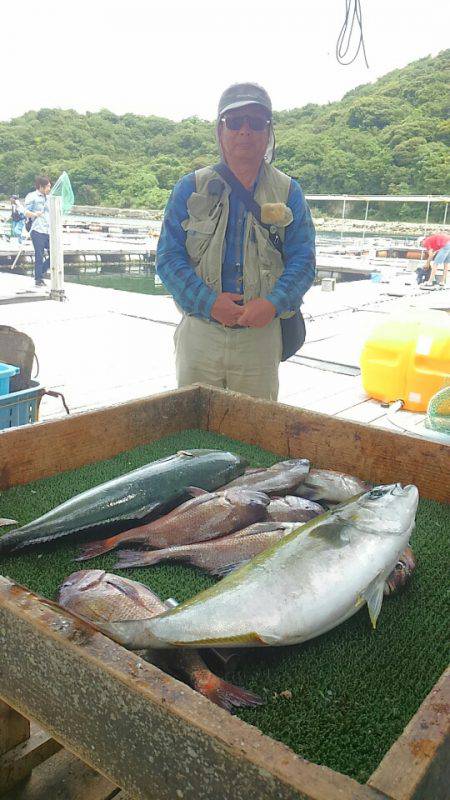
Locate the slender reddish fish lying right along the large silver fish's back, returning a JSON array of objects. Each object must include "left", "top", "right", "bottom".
[{"left": 113, "top": 522, "right": 302, "bottom": 577}]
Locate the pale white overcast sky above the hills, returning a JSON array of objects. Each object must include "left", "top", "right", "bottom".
[{"left": 0, "top": 0, "right": 450, "bottom": 120}]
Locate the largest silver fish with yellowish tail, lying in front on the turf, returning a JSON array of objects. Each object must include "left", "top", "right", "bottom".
[{"left": 93, "top": 483, "right": 419, "bottom": 648}]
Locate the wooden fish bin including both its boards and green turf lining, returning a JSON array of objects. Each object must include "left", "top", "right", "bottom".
[{"left": 0, "top": 386, "right": 450, "bottom": 800}]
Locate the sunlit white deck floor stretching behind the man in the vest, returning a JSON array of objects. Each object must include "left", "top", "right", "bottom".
[{"left": 0, "top": 273, "right": 450, "bottom": 432}]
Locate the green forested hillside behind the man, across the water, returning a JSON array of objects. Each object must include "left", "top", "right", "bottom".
[{"left": 0, "top": 50, "right": 450, "bottom": 208}]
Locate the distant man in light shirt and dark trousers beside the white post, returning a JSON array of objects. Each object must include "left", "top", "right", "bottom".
[{"left": 25, "top": 175, "right": 52, "bottom": 286}]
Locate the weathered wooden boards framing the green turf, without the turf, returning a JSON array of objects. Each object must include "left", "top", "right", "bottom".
[{"left": 0, "top": 386, "right": 450, "bottom": 800}]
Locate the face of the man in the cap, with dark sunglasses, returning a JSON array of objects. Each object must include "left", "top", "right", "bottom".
[{"left": 219, "top": 104, "right": 269, "bottom": 164}]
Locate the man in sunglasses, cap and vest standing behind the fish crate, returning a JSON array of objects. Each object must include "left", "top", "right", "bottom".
[{"left": 157, "top": 83, "right": 315, "bottom": 400}]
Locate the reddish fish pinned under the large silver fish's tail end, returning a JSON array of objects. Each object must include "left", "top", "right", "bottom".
[{"left": 58, "top": 569, "right": 263, "bottom": 711}]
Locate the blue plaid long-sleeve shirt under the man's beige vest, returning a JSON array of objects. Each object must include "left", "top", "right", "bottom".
[{"left": 156, "top": 173, "right": 315, "bottom": 319}]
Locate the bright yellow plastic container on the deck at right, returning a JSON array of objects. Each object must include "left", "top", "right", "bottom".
[{"left": 361, "top": 310, "right": 450, "bottom": 411}]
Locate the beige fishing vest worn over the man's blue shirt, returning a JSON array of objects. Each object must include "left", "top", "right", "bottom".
[{"left": 181, "top": 162, "right": 291, "bottom": 303}]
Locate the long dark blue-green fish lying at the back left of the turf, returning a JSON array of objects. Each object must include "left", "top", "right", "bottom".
[{"left": 0, "top": 449, "right": 246, "bottom": 555}]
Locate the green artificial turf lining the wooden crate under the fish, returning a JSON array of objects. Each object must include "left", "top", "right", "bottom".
[{"left": 0, "top": 430, "right": 449, "bottom": 782}]
